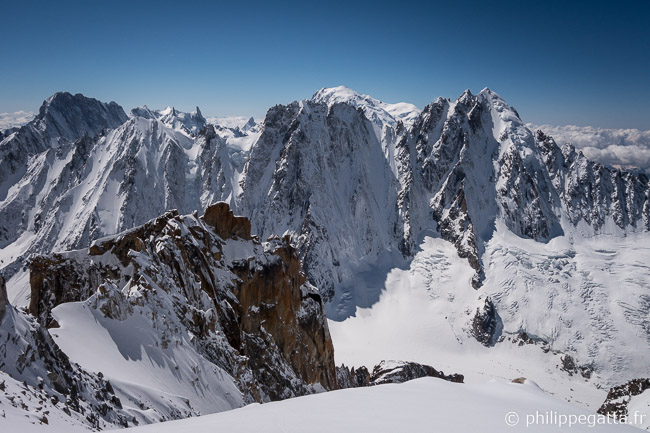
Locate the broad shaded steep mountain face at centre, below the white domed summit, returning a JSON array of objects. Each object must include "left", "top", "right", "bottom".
[{"left": 238, "top": 101, "right": 401, "bottom": 305}]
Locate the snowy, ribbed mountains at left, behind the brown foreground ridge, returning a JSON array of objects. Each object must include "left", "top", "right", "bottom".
[{"left": 0, "top": 93, "right": 257, "bottom": 304}]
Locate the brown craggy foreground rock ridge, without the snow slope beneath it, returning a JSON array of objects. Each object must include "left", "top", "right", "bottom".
[{"left": 30, "top": 203, "right": 337, "bottom": 401}]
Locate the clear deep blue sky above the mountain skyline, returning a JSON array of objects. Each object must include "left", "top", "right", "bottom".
[{"left": 0, "top": 0, "right": 650, "bottom": 129}]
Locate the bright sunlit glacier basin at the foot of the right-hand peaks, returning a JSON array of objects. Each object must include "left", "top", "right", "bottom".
[{"left": 330, "top": 230, "right": 650, "bottom": 410}]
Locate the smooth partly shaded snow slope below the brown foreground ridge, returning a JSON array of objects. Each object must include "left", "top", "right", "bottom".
[{"left": 52, "top": 302, "right": 244, "bottom": 423}]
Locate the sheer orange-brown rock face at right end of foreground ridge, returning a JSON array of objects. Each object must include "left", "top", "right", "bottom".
[{"left": 235, "top": 236, "right": 336, "bottom": 394}]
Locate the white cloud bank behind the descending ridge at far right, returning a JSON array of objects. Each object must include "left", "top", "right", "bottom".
[{"left": 528, "top": 124, "right": 650, "bottom": 174}]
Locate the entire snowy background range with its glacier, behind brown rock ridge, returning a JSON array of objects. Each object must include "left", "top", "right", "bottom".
[{"left": 0, "top": 87, "right": 650, "bottom": 428}]
